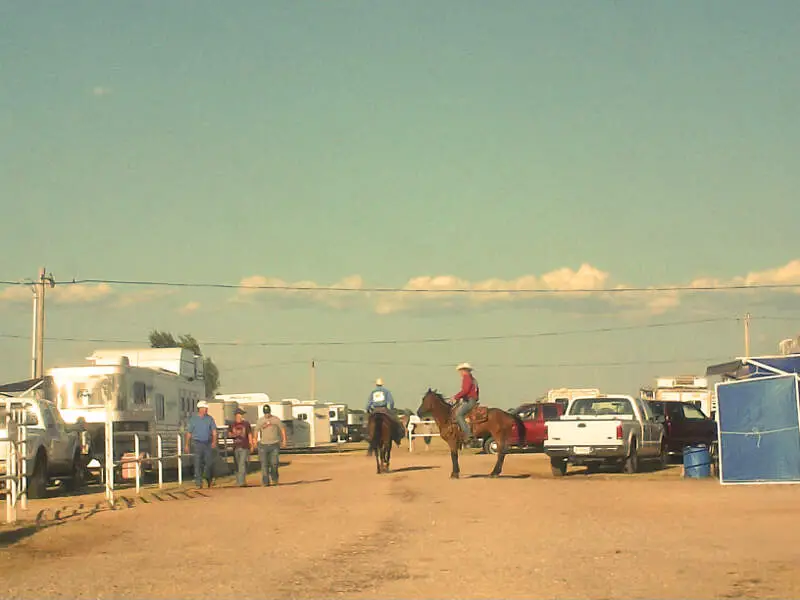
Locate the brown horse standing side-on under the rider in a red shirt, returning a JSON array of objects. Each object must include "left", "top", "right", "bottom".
[{"left": 417, "top": 388, "right": 525, "bottom": 479}]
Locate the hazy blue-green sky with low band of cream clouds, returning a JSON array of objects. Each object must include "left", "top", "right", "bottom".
[{"left": 0, "top": 0, "right": 800, "bottom": 408}]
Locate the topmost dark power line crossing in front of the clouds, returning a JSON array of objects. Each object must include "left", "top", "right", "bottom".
[{"left": 0, "top": 279, "right": 800, "bottom": 295}]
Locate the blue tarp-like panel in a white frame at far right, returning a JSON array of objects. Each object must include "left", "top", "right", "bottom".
[{"left": 717, "top": 375, "right": 800, "bottom": 483}]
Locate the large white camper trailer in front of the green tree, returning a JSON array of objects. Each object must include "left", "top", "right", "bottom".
[{"left": 48, "top": 348, "right": 205, "bottom": 472}]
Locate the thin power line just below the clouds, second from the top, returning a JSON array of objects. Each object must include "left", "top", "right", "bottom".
[{"left": 0, "top": 317, "right": 739, "bottom": 348}]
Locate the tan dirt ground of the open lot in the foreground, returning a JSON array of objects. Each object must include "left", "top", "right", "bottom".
[{"left": 0, "top": 440, "right": 800, "bottom": 600}]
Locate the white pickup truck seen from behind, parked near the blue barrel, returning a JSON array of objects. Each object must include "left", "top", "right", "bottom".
[{"left": 544, "top": 395, "right": 667, "bottom": 476}]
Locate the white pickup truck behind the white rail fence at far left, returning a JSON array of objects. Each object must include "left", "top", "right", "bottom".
[{"left": 0, "top": 397, "right": 88, "bottom": 498}]
